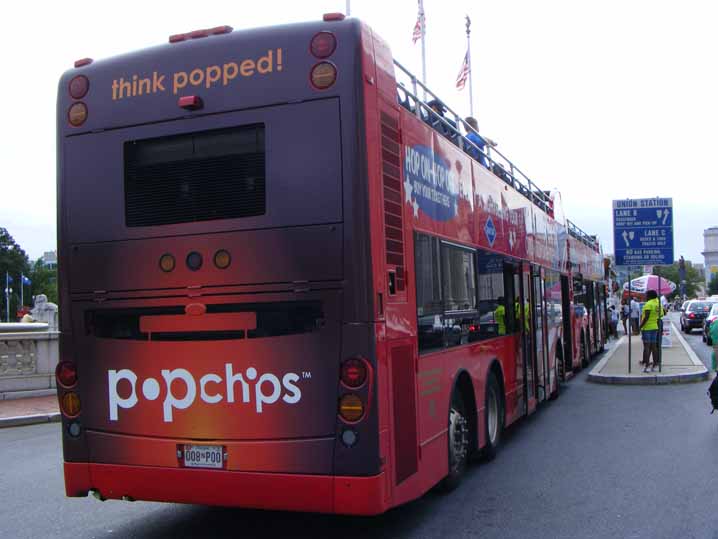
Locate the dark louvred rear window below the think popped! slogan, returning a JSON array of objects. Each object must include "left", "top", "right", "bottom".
[{"left": 124, "top": 125, "right": 266, "bottom": 227}]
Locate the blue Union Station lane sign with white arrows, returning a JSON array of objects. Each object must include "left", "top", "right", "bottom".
[{"left": 613, "top": 198, "right": 673, "bottom": 266}]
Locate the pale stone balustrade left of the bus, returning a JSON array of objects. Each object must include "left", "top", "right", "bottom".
[{"left": 0, "top": 323, "right": 60, "bottom": 400}]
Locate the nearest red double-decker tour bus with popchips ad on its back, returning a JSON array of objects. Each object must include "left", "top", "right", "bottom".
[{"left": 56, "top": 14, "right": 600, "bottom": 515}]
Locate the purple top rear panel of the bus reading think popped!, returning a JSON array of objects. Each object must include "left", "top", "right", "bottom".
[{"left": 58, "top": 21, "right": 360, "bottom": 134}]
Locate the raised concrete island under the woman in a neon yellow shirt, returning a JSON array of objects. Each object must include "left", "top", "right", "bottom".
[{"left": 588, "top": 322, "right": 710, "bottom": 384}]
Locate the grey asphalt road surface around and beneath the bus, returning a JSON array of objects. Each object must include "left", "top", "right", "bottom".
[{"left": 0, "top": 316, "right": 718, "bottom": 539}]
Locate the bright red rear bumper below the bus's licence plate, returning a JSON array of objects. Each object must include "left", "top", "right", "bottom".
[{"left": 64, "top": 462, "right": 389, "bottom": 515}]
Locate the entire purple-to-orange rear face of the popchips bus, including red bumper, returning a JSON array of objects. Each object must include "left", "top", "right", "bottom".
[{"left": 57, "top": 15, "right": 384, "bottom": 513}]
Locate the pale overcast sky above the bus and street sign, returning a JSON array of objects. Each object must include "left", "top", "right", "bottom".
[{"left": 0, "top": 0, "right": 718, "bottom": 262}]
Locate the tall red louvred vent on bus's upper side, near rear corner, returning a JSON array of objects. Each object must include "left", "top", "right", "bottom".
[{"left": 381, "top": 112, "right": 406, "bottom": 291}]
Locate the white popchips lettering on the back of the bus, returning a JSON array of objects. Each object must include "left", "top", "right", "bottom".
[{"left": 107, "top": 363, "right": 311, "bottom": 423}]
